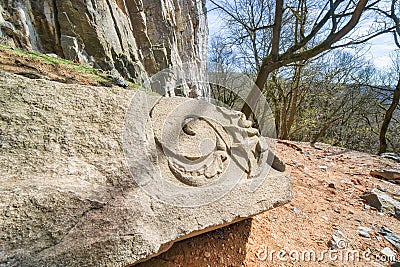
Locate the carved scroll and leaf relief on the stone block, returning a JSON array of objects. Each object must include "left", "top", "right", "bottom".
[{"left": 150, "top": 98, "right": 278, "bottom": 189}]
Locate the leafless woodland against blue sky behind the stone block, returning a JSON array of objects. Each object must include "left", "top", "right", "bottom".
[{"left": 208, "top": 0, "right": 400, "bottom": 153}]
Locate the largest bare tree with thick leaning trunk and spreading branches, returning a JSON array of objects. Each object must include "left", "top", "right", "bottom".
[{"left": 210, "top": 0, "right": 394, "bottom": 118}]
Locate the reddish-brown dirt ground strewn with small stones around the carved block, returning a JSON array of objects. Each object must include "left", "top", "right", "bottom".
[{"left": 0, "top": 47, "right": 400, "bottom": 267}]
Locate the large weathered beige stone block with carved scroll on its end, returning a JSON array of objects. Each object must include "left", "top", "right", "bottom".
[{"left": 0, "top": 73, "right": 292, "bottom": 266}]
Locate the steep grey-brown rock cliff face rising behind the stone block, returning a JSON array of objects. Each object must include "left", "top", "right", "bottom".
[{"left": 0, "top": 0, "right": 207, "bottom": 94}]
